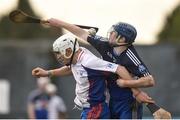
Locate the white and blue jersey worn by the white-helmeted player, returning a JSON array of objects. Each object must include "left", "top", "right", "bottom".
[{"left": 71, "top": 47, "right": 118, "bottom": 107}]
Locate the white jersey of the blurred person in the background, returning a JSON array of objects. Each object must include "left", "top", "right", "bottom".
[{"left": 48, "top": 95, "right": 66, "bottom": 119}]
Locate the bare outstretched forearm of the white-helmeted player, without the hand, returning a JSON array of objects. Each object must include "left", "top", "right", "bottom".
[{"left": 48, "top": 66, "right": 72, "bottom": 76}]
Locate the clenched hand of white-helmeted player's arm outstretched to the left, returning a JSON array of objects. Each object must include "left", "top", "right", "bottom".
[{"left": 32, "top": 67, "right": 48, "bottom": 77}]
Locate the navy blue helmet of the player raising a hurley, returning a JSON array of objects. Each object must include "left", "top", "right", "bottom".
[{"left": 112, "top": 22, "right": 137, "bottom": 43}]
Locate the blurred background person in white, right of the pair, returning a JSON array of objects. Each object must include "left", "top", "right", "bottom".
[{"left": 46, "top": 83, "right": 67, "bottom": 119}]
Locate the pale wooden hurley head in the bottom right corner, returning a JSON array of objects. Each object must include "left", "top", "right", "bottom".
[{"left": 153, "top": 108, "right": 172, "bottom": 119}]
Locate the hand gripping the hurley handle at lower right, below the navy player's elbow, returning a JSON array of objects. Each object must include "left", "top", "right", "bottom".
[{"left": 134, "top": 91, "right": 155, "bottom": 103}]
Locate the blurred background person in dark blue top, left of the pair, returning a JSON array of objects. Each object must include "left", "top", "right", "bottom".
[{"left": 27, "top": 77, "right": 50, "bottom": 119}]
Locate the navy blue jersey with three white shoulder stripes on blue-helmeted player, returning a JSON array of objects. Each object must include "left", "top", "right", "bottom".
[{"left": 87, "top": 36, "right": 150, "bottom": 100}]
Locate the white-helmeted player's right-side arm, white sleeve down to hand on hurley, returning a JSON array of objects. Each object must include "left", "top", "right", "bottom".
[{"left": 82, "top": 55, "right": 154, "bottom": 103}]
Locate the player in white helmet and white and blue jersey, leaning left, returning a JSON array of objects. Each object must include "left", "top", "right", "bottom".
[{"left": 32, "top": 34, "right": 154, "bottom": 119}]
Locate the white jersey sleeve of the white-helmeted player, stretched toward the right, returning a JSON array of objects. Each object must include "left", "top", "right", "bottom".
[{"left": 82, "top": 50, "right": 118, "bottom": 73}]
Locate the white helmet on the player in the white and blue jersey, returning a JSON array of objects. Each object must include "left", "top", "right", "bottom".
[{"left": 53, "top": 33, "right": 79, "bottom": 58}]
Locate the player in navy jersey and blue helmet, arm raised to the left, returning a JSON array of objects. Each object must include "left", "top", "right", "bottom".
[{"left": 44, "top": 18, "right": 170, "bottom": 119}]
